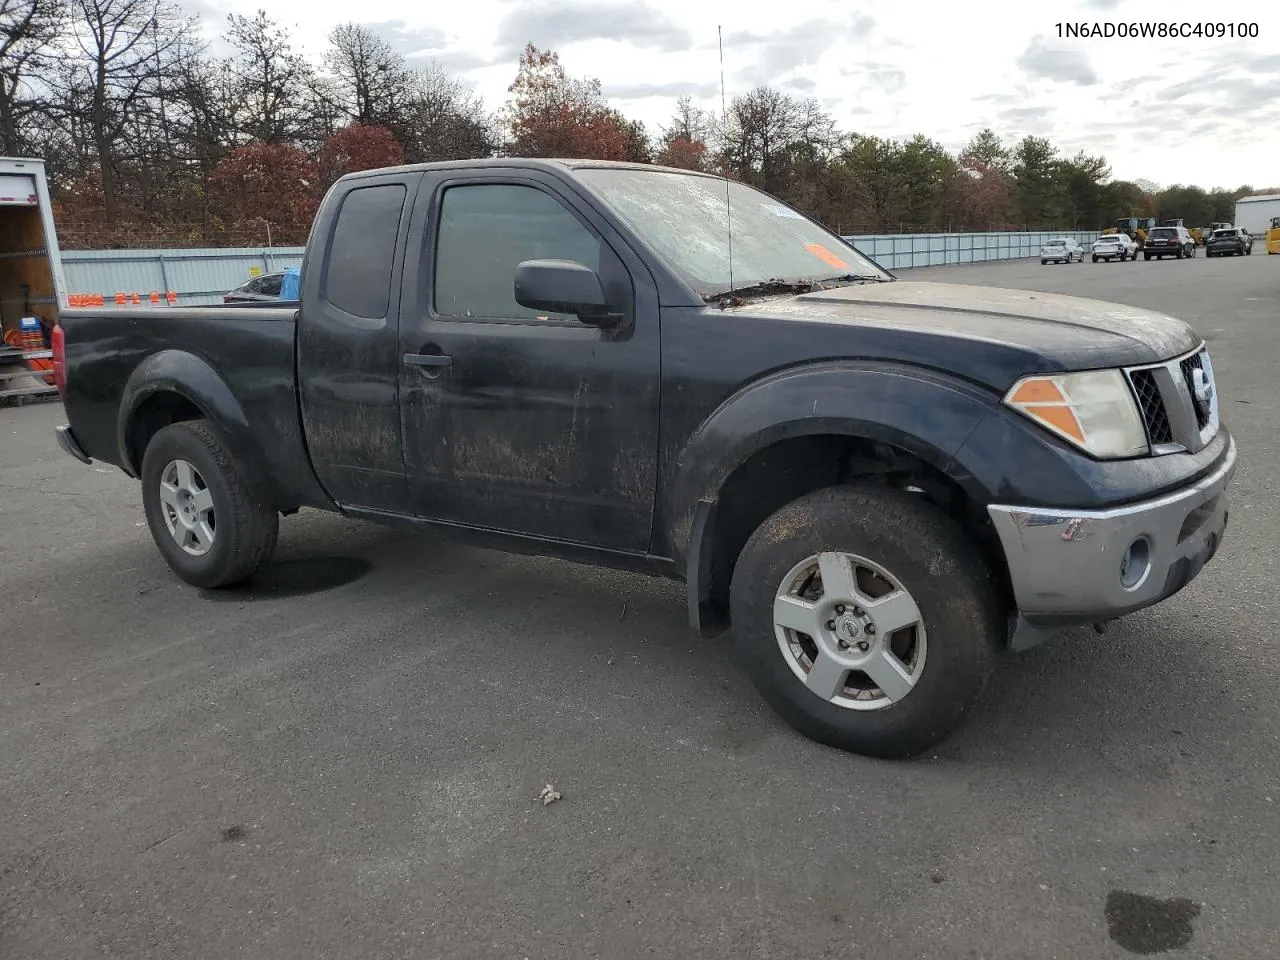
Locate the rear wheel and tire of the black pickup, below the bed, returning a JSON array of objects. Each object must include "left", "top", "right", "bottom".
[{"left": 142, "top": 420, "right": 280, "bottom": 589}]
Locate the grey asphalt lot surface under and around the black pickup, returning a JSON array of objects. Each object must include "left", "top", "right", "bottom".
[{"left": 0, "top": 253, "right": 1280, "bottom": 960}]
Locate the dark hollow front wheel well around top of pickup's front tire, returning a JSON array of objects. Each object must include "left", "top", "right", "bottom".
[{"left": 701, "top": 434, "right": 1012, "bottom": 632}]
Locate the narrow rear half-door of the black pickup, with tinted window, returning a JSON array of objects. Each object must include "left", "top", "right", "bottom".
[{"left": 296, "top": 173, "right": 421, "bottom": 513}]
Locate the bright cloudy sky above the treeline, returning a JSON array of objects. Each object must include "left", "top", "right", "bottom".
[{"left": 195, "top": 0, "right": 1280, "bottom": 188}]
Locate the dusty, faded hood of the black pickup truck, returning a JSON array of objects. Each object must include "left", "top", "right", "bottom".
[{"left": 745, "top": 280, "right": 1201, "bottom": 385}]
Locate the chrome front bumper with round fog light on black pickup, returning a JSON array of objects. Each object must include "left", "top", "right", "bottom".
[{"left": 987, "top": 438, "right": 1236, "bottom": 649}]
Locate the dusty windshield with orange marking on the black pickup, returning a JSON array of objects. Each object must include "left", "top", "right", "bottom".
[{"left": 576, "top": 166, "right": 892, "bottom": 297}]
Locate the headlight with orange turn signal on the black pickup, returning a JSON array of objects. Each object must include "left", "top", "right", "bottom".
[{"left": 1005, "top": 370, "right": 1147, "bottom": 460}]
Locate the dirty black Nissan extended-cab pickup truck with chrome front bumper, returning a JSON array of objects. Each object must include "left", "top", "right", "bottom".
[{"left": 54, "top": 160, "right": 1236, "bottom": 756}]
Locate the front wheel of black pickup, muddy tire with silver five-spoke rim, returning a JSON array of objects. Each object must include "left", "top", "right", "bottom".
[{"left": 730, "top": 486, "right": 1004, "bottom": 759}]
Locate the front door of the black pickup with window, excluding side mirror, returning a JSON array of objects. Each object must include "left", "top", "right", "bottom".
[{"left": 401, "top": 170, "right": 659, "bottom": 553}]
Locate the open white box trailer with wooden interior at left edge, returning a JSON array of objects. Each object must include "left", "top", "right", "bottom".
[{"left": 0, "top": 156, "right": 67, "bottom": 398}]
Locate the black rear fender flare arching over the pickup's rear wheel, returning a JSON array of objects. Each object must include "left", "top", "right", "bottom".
[{"left": 115, "top": 349, "right": 270, "bottom": 483}]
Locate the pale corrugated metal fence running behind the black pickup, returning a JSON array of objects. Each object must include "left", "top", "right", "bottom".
[{"left": 63, "top": 232, "right": 1098, "bottom": 303}]
